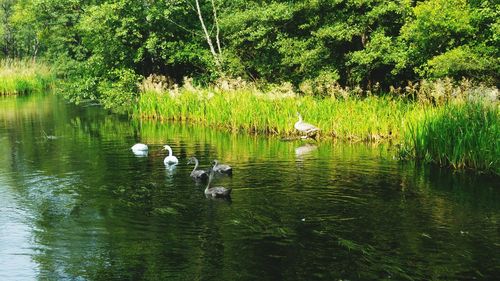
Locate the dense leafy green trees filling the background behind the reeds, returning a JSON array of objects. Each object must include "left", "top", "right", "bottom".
[{"left": 0, "top": 0, "right": 500, "bottom": 102}]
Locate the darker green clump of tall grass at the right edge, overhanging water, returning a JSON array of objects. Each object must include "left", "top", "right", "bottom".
[{"left": 400, "top": 102, "right": 500, "bottom": 175}]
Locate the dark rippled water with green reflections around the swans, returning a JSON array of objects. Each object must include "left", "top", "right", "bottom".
[{"left": 0, "top": 95, "right": 500, "bottom": 280}]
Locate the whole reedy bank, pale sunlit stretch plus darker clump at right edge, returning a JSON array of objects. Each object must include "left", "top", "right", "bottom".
[{"left": 133, "top": 77, "right": 500, "bottom": 174}]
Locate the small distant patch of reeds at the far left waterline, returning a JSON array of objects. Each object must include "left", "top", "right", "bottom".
[{"left": 0, "top": 60, "right": 55, "bottom": 95}]
